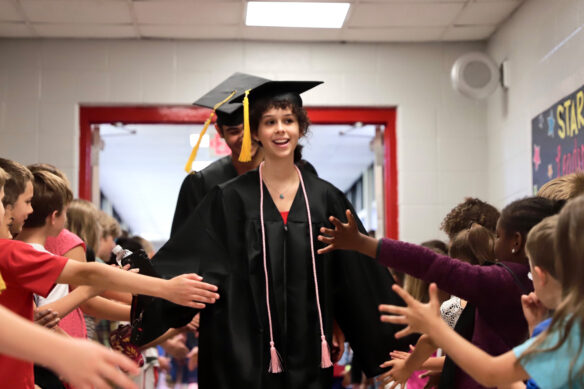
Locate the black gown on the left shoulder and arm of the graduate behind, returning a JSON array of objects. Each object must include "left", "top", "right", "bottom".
[{"left": 170, "top": 155, "right": 237, "bottom": 236}]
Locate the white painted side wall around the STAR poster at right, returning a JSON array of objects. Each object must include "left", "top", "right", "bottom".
[{"left": 487, "top": 0, "right": 584, "bottom": 207}]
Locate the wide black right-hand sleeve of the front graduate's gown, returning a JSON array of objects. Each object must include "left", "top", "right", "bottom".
[{"left": 333, "top": 191, "right": 418, "bottom": 377}]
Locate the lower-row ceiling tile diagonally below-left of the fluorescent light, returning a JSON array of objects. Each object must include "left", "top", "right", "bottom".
[{"left": 139, "top": 24, "right": 240, "bottom": 39}]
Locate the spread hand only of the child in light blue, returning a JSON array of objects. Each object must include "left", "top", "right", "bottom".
[{"left": 379, "top": 283, "right": 442, "bottom": 338}]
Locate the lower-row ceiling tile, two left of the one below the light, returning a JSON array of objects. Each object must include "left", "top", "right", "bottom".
[{"left": 34, "top": 23, "right": 136, "bottom": 38}]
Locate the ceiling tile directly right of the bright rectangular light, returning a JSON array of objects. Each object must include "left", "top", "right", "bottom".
[{"left": 347, "top": 2, "right": 464, "bottom": 27}]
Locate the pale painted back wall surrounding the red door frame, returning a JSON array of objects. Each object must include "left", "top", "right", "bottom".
[{"left": 0, "top": 40, "right": 488, "bottom": 242}]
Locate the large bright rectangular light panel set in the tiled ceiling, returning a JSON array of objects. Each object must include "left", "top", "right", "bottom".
[{"left": 245, "top": 1, "right": 350, "bottom": 28}]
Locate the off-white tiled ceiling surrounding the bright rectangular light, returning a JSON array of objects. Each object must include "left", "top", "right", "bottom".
[{"left": 0, "top": 0, "right": 524, "bottom": 42}]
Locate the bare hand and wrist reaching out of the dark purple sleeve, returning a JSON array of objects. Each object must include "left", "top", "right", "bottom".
[{"left": 318, "top": 209, "right": 379, "bottom": 258}]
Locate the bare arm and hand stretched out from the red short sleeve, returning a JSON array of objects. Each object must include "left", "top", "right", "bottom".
[{"left": 57, "top": 260, "right": 219, "bottom": 309}]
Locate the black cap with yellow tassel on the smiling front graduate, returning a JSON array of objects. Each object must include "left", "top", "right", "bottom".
[{"left": 232, "top": 80, "right": 323, "bottom": 162}]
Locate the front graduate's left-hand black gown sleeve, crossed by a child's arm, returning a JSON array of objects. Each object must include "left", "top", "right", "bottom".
[{"left": 132, "top": 188, "right": 227, "bottom": 345}]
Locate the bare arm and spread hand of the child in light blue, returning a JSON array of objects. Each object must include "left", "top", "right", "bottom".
[{"left": 379, "top": 284, "right": 529, "bottom": 387}]
